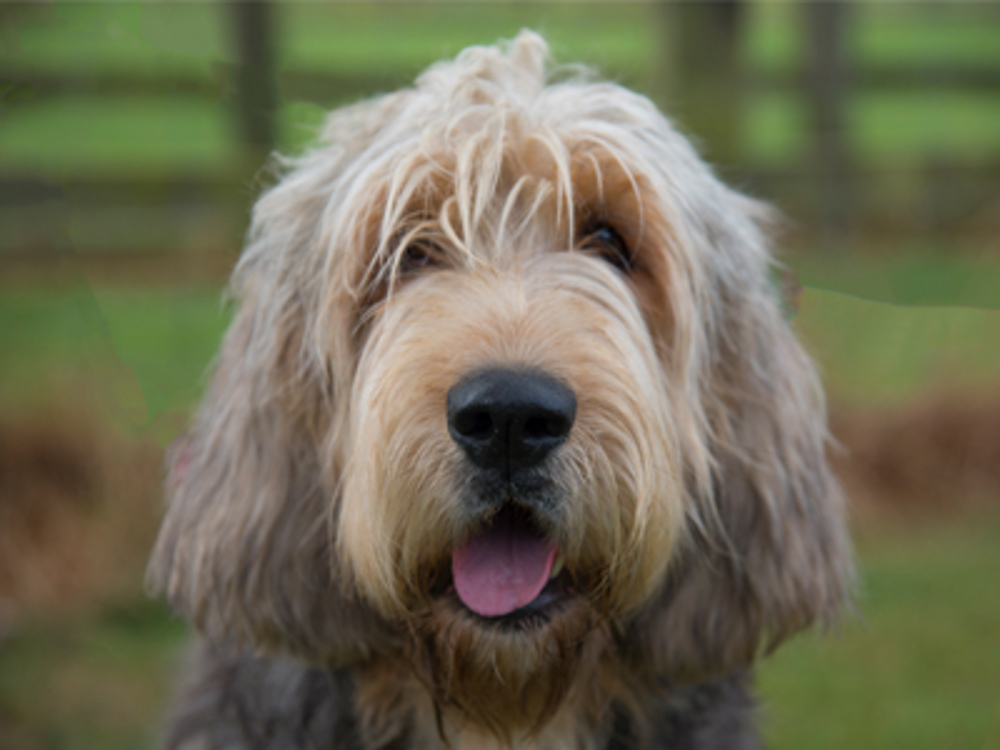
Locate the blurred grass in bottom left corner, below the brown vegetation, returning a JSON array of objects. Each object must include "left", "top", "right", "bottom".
[{"left": 0, "top": 600, "right": 187, "bottom": 750}]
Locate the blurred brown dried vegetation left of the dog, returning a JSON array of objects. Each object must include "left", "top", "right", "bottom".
[{"left": 0, "top": 413, "right": 161, "bottom": 629}]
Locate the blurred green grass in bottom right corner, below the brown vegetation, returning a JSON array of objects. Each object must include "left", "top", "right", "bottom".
[{"left": 759, "top": 517, "right": 1000, "bottom": 750}]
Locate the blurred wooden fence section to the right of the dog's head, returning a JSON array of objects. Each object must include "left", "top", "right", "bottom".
[{"left": 667, "top": 0, "right": 1000, "bottom": 249}]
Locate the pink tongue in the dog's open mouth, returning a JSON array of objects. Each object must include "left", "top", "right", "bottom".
[{"left": 451, "top": 511, "right": 556, "bottom": 617}]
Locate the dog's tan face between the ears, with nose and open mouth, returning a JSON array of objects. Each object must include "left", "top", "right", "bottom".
[{"left": 344, "top": 153, "right": 691, "bottom": 632}]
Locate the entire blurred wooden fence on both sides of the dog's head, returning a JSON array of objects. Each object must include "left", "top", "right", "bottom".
[{"left": 0, "top": 0, "right": 1000, "bottom": 274}]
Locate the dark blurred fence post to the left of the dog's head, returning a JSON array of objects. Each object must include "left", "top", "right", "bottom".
[{"left": 229, "top": 0, "right": 278, "bottom": 168}]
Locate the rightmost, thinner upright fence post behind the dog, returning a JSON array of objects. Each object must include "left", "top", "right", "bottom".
[{"left": 802, "top": 2, "right": 851, "bottom": 250}]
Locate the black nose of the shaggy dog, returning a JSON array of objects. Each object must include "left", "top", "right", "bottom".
[{"left": 448, "top": 369, "right": 576, "bottom": 473}]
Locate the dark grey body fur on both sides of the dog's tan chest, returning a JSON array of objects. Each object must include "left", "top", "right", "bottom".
[{"left": 164, "top": 644, "right": 762, "bottom": 750}]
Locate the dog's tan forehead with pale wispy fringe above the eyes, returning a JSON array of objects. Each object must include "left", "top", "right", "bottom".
[{"left": 383, "top": 110, "right": 657, "bottom": 251}]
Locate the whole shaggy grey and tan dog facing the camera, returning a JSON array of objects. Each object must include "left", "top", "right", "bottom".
[{"left": 152, "top": 32, "right": 850, "bottom": 750}]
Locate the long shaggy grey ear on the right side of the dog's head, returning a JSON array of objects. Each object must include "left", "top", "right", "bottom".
[{"left": 629, "top": 186, "right": 852, "bottom": 682}]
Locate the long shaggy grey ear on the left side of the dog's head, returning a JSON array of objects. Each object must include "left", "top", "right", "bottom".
[{"left": 150, "top": 120, "right": 385, "bottom": 662}]
